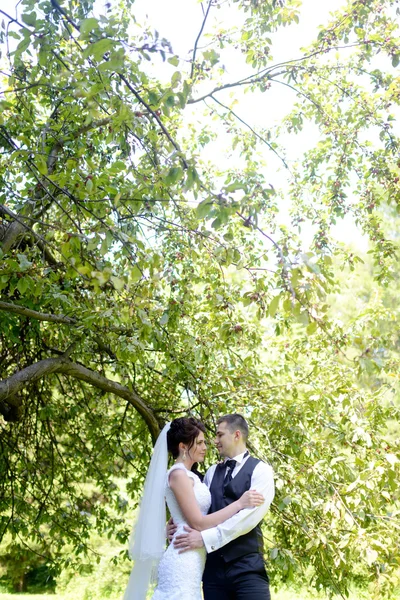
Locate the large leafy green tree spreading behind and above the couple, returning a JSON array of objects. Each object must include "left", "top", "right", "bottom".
[{"left": 0, "top": 0, "right": 400, "bottom": 597}]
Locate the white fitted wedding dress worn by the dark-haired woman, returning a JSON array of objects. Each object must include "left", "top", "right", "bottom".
[{"left": 152, "top": 463, "right": 211, "bottom": 600}]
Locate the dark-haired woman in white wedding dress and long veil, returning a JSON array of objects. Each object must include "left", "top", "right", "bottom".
[{"left": 124, "top": 417, "right": 264, "bottom": 600}]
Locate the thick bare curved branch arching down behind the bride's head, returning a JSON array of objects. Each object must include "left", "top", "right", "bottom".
[{"left": 0, "top": 356, "right": 160, "bottom": 442}]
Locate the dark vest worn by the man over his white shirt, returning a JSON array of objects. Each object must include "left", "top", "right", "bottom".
[{"left": 208, "top": 456, "right": 264, "bottom": 562}]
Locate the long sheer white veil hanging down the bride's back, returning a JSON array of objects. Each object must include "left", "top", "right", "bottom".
[{"left": 124, "top": 423, "right": 171, "bottom": 600}]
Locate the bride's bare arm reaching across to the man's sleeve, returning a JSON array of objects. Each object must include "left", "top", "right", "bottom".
[{"left": 169, "top": 469, "right": 264, "bottom": 531}]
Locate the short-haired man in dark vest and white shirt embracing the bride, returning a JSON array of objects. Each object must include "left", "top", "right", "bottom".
[{"left": 174, "top": 414, "right": 274, "bottom": 600}]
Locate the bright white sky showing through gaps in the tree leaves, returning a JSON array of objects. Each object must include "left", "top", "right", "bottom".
[{"left": 1, "top": 0, "right": 366, "bottom": 250}]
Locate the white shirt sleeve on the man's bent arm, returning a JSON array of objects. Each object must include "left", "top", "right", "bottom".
[{"left": 201, "top": 462, "right": 275, "bottom": 552}]
